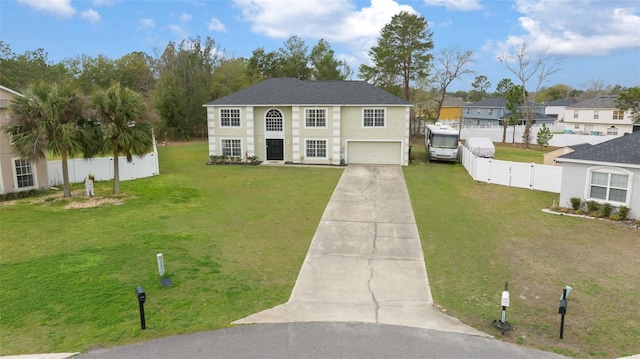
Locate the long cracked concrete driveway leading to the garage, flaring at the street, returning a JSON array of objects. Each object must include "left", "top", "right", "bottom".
[{"left": 234, "top": 165, "right": 488, "bottom": 336}]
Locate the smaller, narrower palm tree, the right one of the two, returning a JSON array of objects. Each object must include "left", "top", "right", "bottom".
[{"left": 93, "top": 83, "right": 153, "bottom": 194}]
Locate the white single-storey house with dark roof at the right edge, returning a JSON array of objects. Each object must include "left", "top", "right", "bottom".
[{"left": 556, "top": 132, "right": 640, "bottom": 219}]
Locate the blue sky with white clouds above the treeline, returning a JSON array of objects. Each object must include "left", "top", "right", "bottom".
[{"left": 0, "top": 0, "right": 640, "bottom": 91}]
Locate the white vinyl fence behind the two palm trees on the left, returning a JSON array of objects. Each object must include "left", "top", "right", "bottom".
[{"left": 47, "top": 146, "right": 160, "bottom": 186}]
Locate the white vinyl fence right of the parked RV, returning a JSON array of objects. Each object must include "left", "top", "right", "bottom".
[{"left": 460, "top": 146, "right": 562, "bottom": 193}]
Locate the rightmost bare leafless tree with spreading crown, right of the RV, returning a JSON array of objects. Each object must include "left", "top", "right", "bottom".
[{"left": 499, "top": 43, "right": 560, "bottom": 149}]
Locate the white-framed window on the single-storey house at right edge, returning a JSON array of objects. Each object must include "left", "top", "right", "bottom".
[{"left": 589, "top": 169, "right": 630, "bottom": 203}]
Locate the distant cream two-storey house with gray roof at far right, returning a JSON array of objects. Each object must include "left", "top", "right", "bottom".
[{"left": 564, "top": 95, "right": 633, "bottom": 135}]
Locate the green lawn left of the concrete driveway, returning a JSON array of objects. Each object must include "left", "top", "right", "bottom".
[{"left": 0, "top": 142, "right": 342, "bottom": 355}]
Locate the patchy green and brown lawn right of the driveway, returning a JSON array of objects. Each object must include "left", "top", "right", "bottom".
[{"left": 404, "top": 142, "right": 640, "bottom": 358}]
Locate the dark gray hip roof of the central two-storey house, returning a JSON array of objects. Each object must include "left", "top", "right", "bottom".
[{"left": 204, "top": 78, "right": 411, "bottom": 106}]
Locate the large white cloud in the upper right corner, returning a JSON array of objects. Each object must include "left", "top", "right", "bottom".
[{"left": 499, "top": 0, "right": 640, "bottom": 56}]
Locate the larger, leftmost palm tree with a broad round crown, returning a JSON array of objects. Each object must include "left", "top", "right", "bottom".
[{"left": 4, "top": 82, "right": 95, "bottom": 198}]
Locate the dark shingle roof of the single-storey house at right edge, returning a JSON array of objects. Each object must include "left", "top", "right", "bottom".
[{"left": 556, "top": 131, "right": 640, "bottom": 165}]
